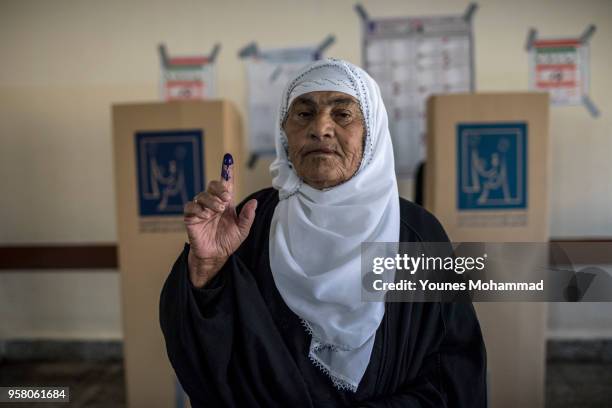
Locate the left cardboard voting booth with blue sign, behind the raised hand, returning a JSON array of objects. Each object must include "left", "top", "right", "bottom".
[{"left": 113, "top": 100, "right": 244, "bottom": 407}]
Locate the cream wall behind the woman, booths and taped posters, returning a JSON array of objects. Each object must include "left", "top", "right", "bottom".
[{"left": 0, "top": 0, "right": 612, "bottom": 338}]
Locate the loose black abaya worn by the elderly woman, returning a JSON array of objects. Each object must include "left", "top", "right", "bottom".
[{"left": 160, "top": 188, "right": 486, "bottom": 408}]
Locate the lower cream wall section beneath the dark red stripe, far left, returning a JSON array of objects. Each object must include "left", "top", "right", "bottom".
[{"left": 0, "top": 270, "right": 122, "bottom": 340}]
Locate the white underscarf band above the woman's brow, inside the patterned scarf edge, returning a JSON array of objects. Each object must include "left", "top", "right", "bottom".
[{"left": 287, "top": 65, "right": 359, "bottom": 107}]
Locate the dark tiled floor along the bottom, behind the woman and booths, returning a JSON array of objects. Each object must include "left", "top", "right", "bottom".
[{"left": 0, "top": 361, "right": 612, "bottom": 408}]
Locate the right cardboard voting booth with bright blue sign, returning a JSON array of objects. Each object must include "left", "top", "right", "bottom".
[{"left": 424, "top": 93, "right": 550, "bottom": 408}]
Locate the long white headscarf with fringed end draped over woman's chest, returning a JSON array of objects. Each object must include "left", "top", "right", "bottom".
[{"left": 270, "top": 59, "right": 400, "bottom": 392}]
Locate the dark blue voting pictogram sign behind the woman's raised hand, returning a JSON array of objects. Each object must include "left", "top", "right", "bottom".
[{"left": 134, "top": 130, "right": 204, "bottom": 216}]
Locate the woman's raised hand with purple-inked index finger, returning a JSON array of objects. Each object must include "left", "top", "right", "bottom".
[{"left": 183, "top": 153, "right": 257, "bottom": 288}]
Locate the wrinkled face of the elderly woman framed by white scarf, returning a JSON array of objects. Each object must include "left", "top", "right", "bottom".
[{"left": 283, "top": 91, "right": 365, "bottom": 189}]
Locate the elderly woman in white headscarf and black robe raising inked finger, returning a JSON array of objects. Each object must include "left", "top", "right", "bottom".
[{"left": 160, "top": 59, "right": 486, "bottom": 408}]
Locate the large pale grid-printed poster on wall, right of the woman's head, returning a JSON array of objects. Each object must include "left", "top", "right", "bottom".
[{"left": 358, "top": 7, "right": 475, "bottom": 178}]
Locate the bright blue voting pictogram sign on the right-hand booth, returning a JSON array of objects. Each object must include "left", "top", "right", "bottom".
[{"left": 457, "top": 122, "right": 527, "bottom": 210}]
